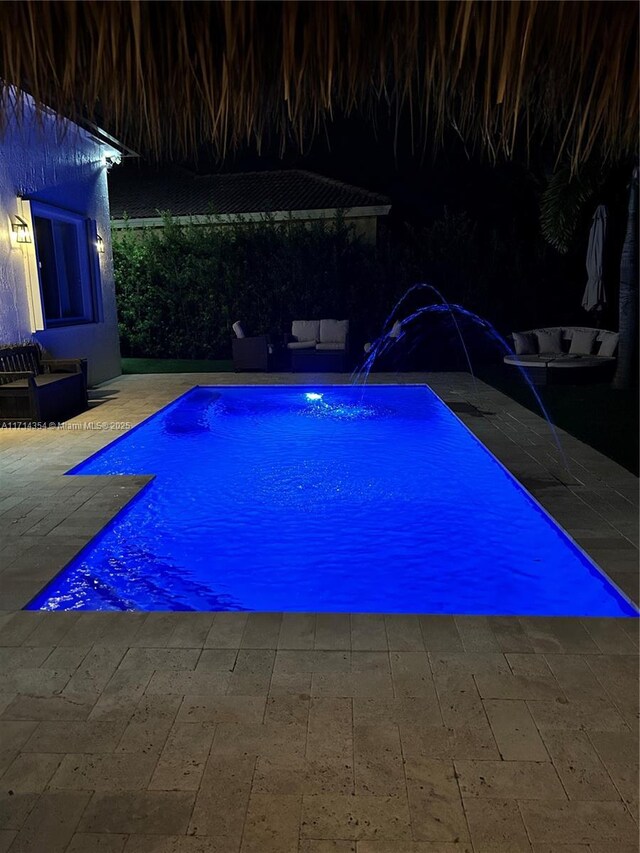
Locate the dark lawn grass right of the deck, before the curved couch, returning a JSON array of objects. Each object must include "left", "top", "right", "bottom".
[{"left": 478, "top": 367, "right": 638, "bottom": 475}]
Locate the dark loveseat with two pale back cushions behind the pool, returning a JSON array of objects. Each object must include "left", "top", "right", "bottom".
[{"left": 286, "top": 320, "right": 349, "bottom": 372}]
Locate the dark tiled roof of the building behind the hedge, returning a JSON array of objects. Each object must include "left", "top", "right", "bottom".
[{"left": 109, "top": 169, "right": 391, "bottom": 219}]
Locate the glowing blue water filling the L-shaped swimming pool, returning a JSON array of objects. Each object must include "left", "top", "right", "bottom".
[{"left": 29, "top": 386, "right": 636, "bottom": 616}]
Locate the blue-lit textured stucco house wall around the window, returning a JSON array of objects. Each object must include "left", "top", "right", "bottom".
[{"left": 0, "top": 98, "right": 121, "bottom": 384}]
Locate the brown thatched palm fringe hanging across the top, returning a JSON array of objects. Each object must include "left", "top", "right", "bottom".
[{"left": 0, "top": 0, "right": 638, "bottom": 164}]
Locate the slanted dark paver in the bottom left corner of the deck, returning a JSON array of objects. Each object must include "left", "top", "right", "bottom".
[{"left": 6, "top": 791, "right": 91, "bottom": 853}]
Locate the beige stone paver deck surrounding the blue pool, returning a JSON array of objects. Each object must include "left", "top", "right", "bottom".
[{"left": 0, "top": 374, "right": 638, "bottom": 853}]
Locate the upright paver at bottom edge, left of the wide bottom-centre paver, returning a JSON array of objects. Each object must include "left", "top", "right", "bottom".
[{"left": 240, "top": 793, "right": 302, "bottom": 853}]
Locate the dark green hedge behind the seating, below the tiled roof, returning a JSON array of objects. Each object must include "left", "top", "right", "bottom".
[{"left": 113, "top": 212, "right": 514, "bottom": 359}]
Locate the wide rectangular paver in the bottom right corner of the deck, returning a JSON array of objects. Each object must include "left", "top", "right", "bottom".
[{"left": 520, "top": 800, "right": 638, "bottom": 846}]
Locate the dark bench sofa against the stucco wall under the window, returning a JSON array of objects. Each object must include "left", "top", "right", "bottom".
[{"left": 0, "top": 344, "right": 89, "bottom": 425}]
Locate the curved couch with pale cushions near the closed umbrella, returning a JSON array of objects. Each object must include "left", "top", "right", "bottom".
[{"left": 504, "top": 326, "right": 619, "bottom": 385}]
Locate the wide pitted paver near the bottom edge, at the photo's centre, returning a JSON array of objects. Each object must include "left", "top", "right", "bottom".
[{"left": 300, "top": 794, "right": 411, "bottom": 841}]
